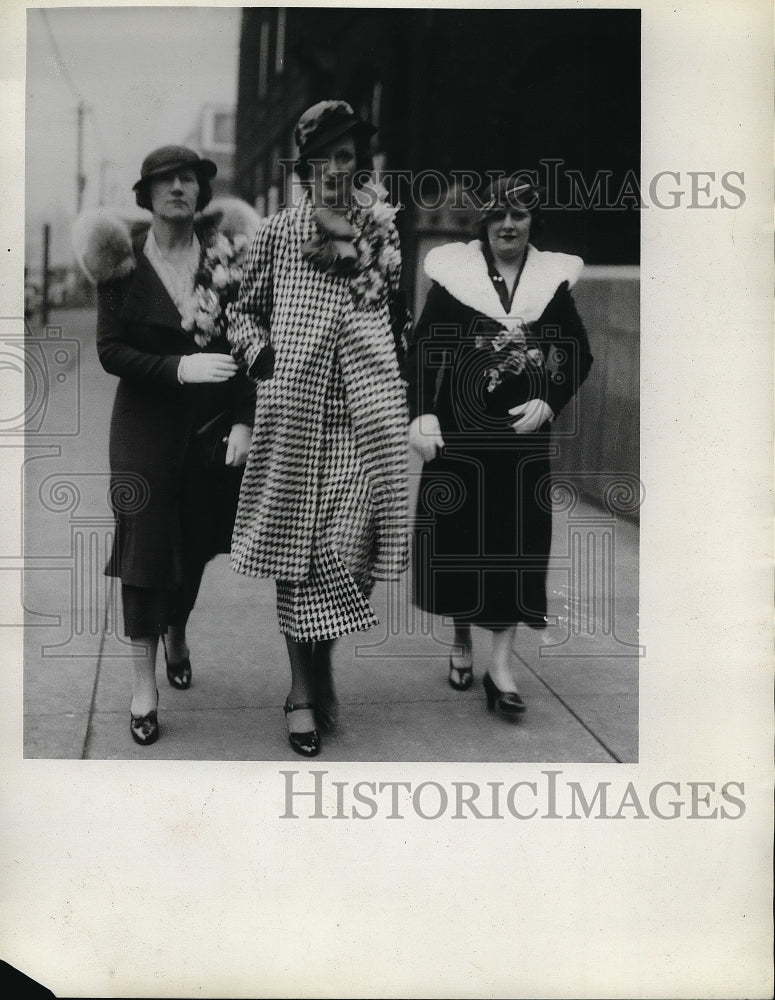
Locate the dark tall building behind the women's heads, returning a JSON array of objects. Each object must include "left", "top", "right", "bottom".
[{"left": 235, "top": 7, "right": 640, "bottom": 297}]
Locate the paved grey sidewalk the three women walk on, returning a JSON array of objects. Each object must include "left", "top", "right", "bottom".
[{"left": 24, "top": 312, "right": 640, "bottom": 763}]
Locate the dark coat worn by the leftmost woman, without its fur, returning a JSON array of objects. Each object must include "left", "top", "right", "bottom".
[{"left": 97, "top": 235, "right": 255, "bottom": 589}]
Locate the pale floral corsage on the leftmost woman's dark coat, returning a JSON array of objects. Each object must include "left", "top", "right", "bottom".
[{"left": 181, "top": 232, "right": 250, "bottom": 347}]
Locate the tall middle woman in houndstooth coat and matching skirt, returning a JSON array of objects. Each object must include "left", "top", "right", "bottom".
[{"left": 228, "top": 101, "right": 408, "bottom": 756}]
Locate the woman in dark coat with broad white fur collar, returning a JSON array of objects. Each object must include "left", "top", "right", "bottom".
[{"left": 406, "top": 178, "right": 592, "bottom": 719}]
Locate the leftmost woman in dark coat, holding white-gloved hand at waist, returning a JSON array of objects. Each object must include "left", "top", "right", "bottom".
[{"left": 90, "top": 146, "right": 255, "bottom": 745}]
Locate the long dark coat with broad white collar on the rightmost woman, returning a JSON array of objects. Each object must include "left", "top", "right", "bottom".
[{"left": 406, "top": 241, "right": 592, "bottom": 628}]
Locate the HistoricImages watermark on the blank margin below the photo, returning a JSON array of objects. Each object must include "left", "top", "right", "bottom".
[{"left": 279, "top": 769, "right": 746, "bottom": 820}]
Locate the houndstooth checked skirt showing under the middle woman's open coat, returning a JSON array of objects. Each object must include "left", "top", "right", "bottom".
[{"left": 276, "top": 363, "right": 378, "bottom": 642}]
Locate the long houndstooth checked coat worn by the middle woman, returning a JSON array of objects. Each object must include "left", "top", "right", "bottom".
[{"left": 228, "top": 194, "right": 408, "bottom": 581}]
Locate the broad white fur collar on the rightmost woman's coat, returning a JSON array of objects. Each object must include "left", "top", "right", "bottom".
[{"left": 425, "top": 240, "right": 584, "bottom": 326}]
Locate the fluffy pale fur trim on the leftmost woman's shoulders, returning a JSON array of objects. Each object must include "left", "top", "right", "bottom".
[{"left": 72, "top": 196, "right": 261, "bottom": 285}]
